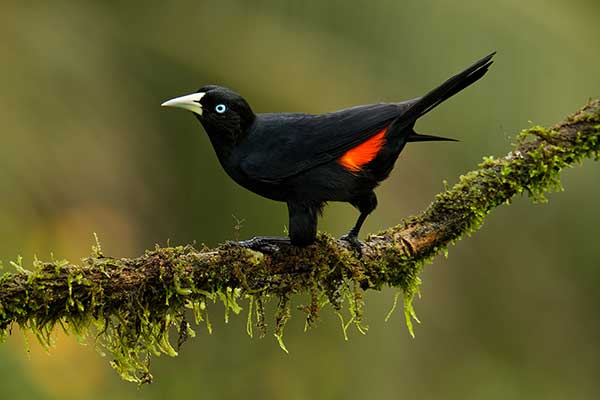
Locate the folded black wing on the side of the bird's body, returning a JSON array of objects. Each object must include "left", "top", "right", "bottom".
[{"left": 239, "top": 101, "right": 411, "bottom": 183}]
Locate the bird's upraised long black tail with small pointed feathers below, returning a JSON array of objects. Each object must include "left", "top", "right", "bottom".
[{"left": 400, "top": 52, "right": 496, "bottom": 142}]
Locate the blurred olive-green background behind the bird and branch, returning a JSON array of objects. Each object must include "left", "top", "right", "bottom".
[{"left": 0, "top": 0, "right": 600, "bottom": 400}]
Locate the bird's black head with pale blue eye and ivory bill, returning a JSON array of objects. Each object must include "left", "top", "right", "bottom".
[{"left": 162, "top": 85, "right": 256, "bottom": 145}]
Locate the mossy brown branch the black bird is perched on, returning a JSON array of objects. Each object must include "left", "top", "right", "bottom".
[{"left": 0, "top": 100, "right": 600, "bottom": 382}]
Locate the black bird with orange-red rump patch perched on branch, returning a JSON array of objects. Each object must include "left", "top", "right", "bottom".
[{"left": 162, "top": 52, "right": 496, "bottom": 256}]
